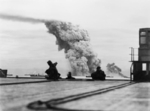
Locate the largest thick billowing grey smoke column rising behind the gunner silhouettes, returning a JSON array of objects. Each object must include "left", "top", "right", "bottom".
[{"left": 45, "top": 21, "right": 101, "bottom": 75}]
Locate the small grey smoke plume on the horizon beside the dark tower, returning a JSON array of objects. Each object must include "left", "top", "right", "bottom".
[{"left": 106, "top": 63, "right": 128, "bottom": 78}]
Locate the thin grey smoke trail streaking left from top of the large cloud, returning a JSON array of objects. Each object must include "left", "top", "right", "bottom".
[{"left": 0, "top": 14, "right": 47, "bottom": 23}]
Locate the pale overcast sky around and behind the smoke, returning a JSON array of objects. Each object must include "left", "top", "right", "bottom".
[{"left": 0, "top": 0, "right": 150, "bottom": 76}]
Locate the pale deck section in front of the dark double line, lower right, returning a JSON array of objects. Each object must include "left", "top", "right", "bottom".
[{"left": 58, "top": 83, "right": 150, "bottom": 111}]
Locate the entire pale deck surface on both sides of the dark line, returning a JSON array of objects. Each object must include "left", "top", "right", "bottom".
[{"left": 0, "top": 79, "right": 150, "bottom": 111}]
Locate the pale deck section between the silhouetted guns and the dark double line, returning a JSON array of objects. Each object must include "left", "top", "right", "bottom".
[{"left": 0, "top": 81, "right": 128, "bottom": 111}]
